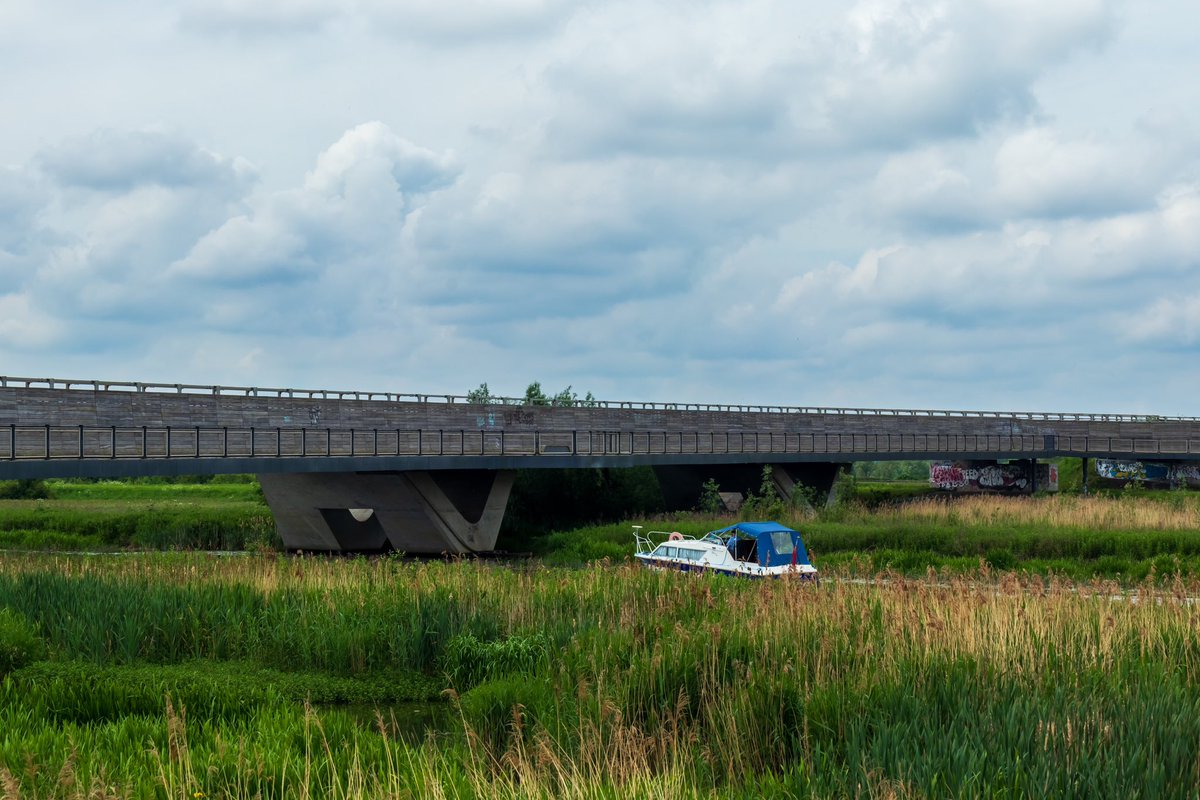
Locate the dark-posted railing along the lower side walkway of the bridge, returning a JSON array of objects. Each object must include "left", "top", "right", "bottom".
[{"left": 0, "top": 425, "right": 1200, "bottom": 462}]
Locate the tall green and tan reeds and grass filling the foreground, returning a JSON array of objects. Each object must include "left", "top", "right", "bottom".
[{"left": 0, "top": 554, "right": 1200, "bottom": 800}]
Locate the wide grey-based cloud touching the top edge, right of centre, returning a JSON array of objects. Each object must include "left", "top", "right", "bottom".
[{"left": 546, "top": 0, "right": 1112, "bottom": 158}]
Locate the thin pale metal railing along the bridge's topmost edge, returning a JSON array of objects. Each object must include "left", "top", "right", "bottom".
[{"left": 0, "top": 375, "right": 1200, "bottom": 423}]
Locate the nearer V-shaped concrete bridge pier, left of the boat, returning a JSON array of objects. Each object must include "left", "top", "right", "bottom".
[{"left": 258, "top": 470, "right": 516, "bottom": 553}]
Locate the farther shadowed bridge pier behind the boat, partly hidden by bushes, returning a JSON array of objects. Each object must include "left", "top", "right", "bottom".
[{"left": 654, "top": 463, "right": 845, "bottom": 510}]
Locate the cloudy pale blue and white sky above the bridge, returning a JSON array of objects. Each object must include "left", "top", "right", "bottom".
[{"left": 0, "top": 0, "right": 1200, "bottom": 415}]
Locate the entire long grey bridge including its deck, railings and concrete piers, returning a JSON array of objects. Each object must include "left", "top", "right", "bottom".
[{"left": 0, "top": 377, "right": 1200, "bottom": 553}]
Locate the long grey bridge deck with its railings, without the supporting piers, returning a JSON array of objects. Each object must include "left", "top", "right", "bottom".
[{"left": 0, "top": 378, "right": 1200, "bottom": 477}]
